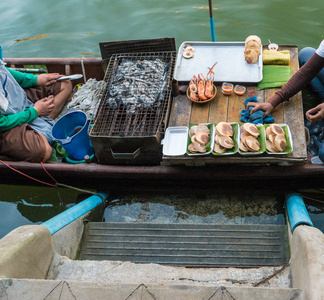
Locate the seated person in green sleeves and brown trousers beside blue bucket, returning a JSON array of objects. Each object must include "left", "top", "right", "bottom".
[{"left": 0, "top": 60, "right": 72, "bottom": 162}]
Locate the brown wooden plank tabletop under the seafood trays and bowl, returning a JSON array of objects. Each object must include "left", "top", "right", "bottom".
[{"left": 163, "top": 45, "right": 307, "bottom": 165}]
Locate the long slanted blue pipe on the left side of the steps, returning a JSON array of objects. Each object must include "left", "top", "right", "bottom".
[{"left": 41, "top": 193, "right": 107, "bottom": 234}]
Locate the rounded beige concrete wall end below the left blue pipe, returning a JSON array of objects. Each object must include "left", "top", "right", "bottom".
[{"left": 0, "top": 225, "right": 54, "bottom": 279}]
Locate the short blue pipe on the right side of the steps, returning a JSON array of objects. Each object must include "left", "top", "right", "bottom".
[{"left": 286, "top": 193, "right": 314, "bottom": 231}]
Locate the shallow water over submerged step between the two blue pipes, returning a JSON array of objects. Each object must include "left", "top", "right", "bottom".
[{"left": 104, "top": 189, "right": 285, "bottom": 225}]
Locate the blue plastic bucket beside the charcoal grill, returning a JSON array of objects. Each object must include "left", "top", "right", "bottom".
[{"left": 52, "top": 111, "right": 93, "bottom": 160}]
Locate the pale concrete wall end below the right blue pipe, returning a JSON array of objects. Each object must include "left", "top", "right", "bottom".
[{"left": 291, "top": 225, "right": 324, "bottom": 300}]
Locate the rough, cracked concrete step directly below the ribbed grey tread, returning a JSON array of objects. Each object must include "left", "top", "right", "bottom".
[{"left": 46, "top": 256, "right": 292, "bottom": 288}]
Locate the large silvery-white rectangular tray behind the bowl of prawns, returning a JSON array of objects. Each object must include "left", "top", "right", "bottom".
[{"left": 174, "top": 41, "right": 263, "bottom": 83}]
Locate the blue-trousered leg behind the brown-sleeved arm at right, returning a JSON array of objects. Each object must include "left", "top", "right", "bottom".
[{"left": 298, "top": 47, "right": 324, "bottom": 101}]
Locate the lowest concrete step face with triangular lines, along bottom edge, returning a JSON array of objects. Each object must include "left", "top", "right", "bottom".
[{"left": 0, "top": 279, "right": 302, "bottom": 300}]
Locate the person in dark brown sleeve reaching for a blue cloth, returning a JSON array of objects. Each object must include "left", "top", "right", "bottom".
[{"left": 247, "top": 40, "right": 324, "bottom": 122}]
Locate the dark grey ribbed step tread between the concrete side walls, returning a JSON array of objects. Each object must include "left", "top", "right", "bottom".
[{"left": 79, "top": 223, "right": 289, "bottom": 267}]
